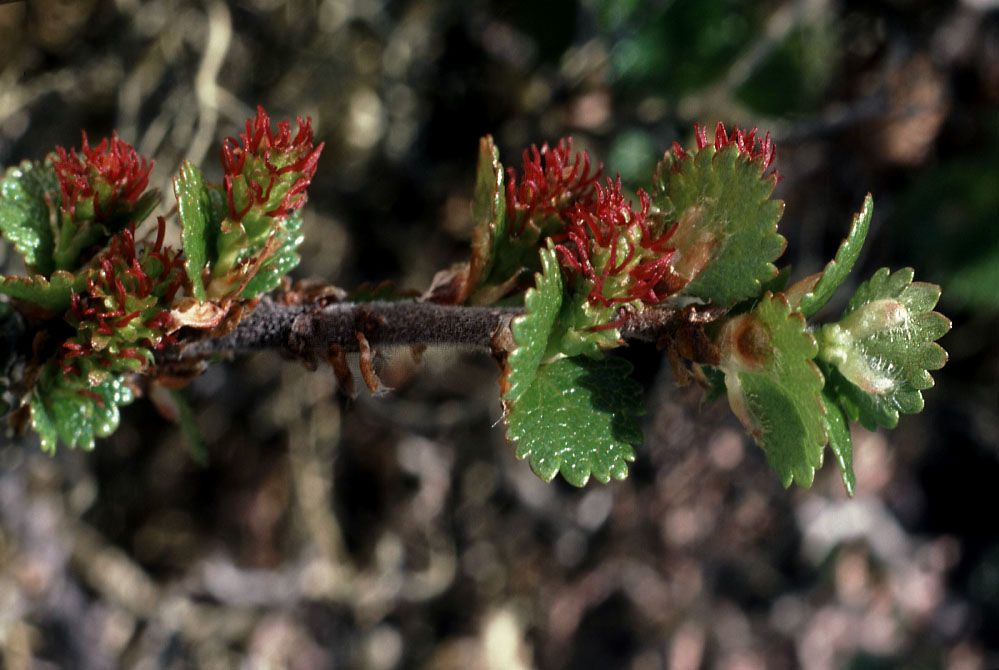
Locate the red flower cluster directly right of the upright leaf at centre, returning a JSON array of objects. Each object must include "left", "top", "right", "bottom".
[{"left": 506, "top": 138, "right": 603, "bottom": 235}]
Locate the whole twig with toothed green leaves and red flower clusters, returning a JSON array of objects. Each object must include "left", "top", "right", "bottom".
[{"left": 0, "top": 109, "right": 950, "bottom": 493}]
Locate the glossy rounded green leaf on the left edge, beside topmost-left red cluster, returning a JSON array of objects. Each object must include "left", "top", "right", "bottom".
[{"left": 0, "top": 161, "right": 61, "bottom": 276}]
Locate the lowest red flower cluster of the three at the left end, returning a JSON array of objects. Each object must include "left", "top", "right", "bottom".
[{"left": 60, "top": 216, "right": 184, "bottom": 374}]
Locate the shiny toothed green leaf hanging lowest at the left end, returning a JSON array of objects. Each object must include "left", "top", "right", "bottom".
[{"left": 31, "top": 364, "right": 134, "bottom": 452}]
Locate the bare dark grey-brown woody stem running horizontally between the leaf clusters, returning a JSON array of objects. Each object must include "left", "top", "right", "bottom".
[{"left": 158, "top": 297, "right": 720, "bottom": 362}]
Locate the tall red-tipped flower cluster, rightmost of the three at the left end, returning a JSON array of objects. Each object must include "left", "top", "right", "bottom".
[{"left": 222, "top": 105, "right": 325, "bottom": 221}]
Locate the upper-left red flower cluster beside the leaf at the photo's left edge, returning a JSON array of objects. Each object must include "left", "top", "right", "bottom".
[{"left": 52, "top": 132, "right": 154, "bottom": 220}]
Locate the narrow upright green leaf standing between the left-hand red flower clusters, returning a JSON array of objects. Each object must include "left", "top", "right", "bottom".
[{"left": 173, "top": 161, "right": 219, "bottom": 303}]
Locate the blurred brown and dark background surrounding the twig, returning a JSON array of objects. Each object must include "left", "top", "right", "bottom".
[{"left": 0, "top": 0, "right": 999, "bottom": 670}]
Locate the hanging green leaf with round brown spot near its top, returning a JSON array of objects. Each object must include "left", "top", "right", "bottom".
[{"left": 720, "top": 294, "right": 826, "bottom": 488}]
